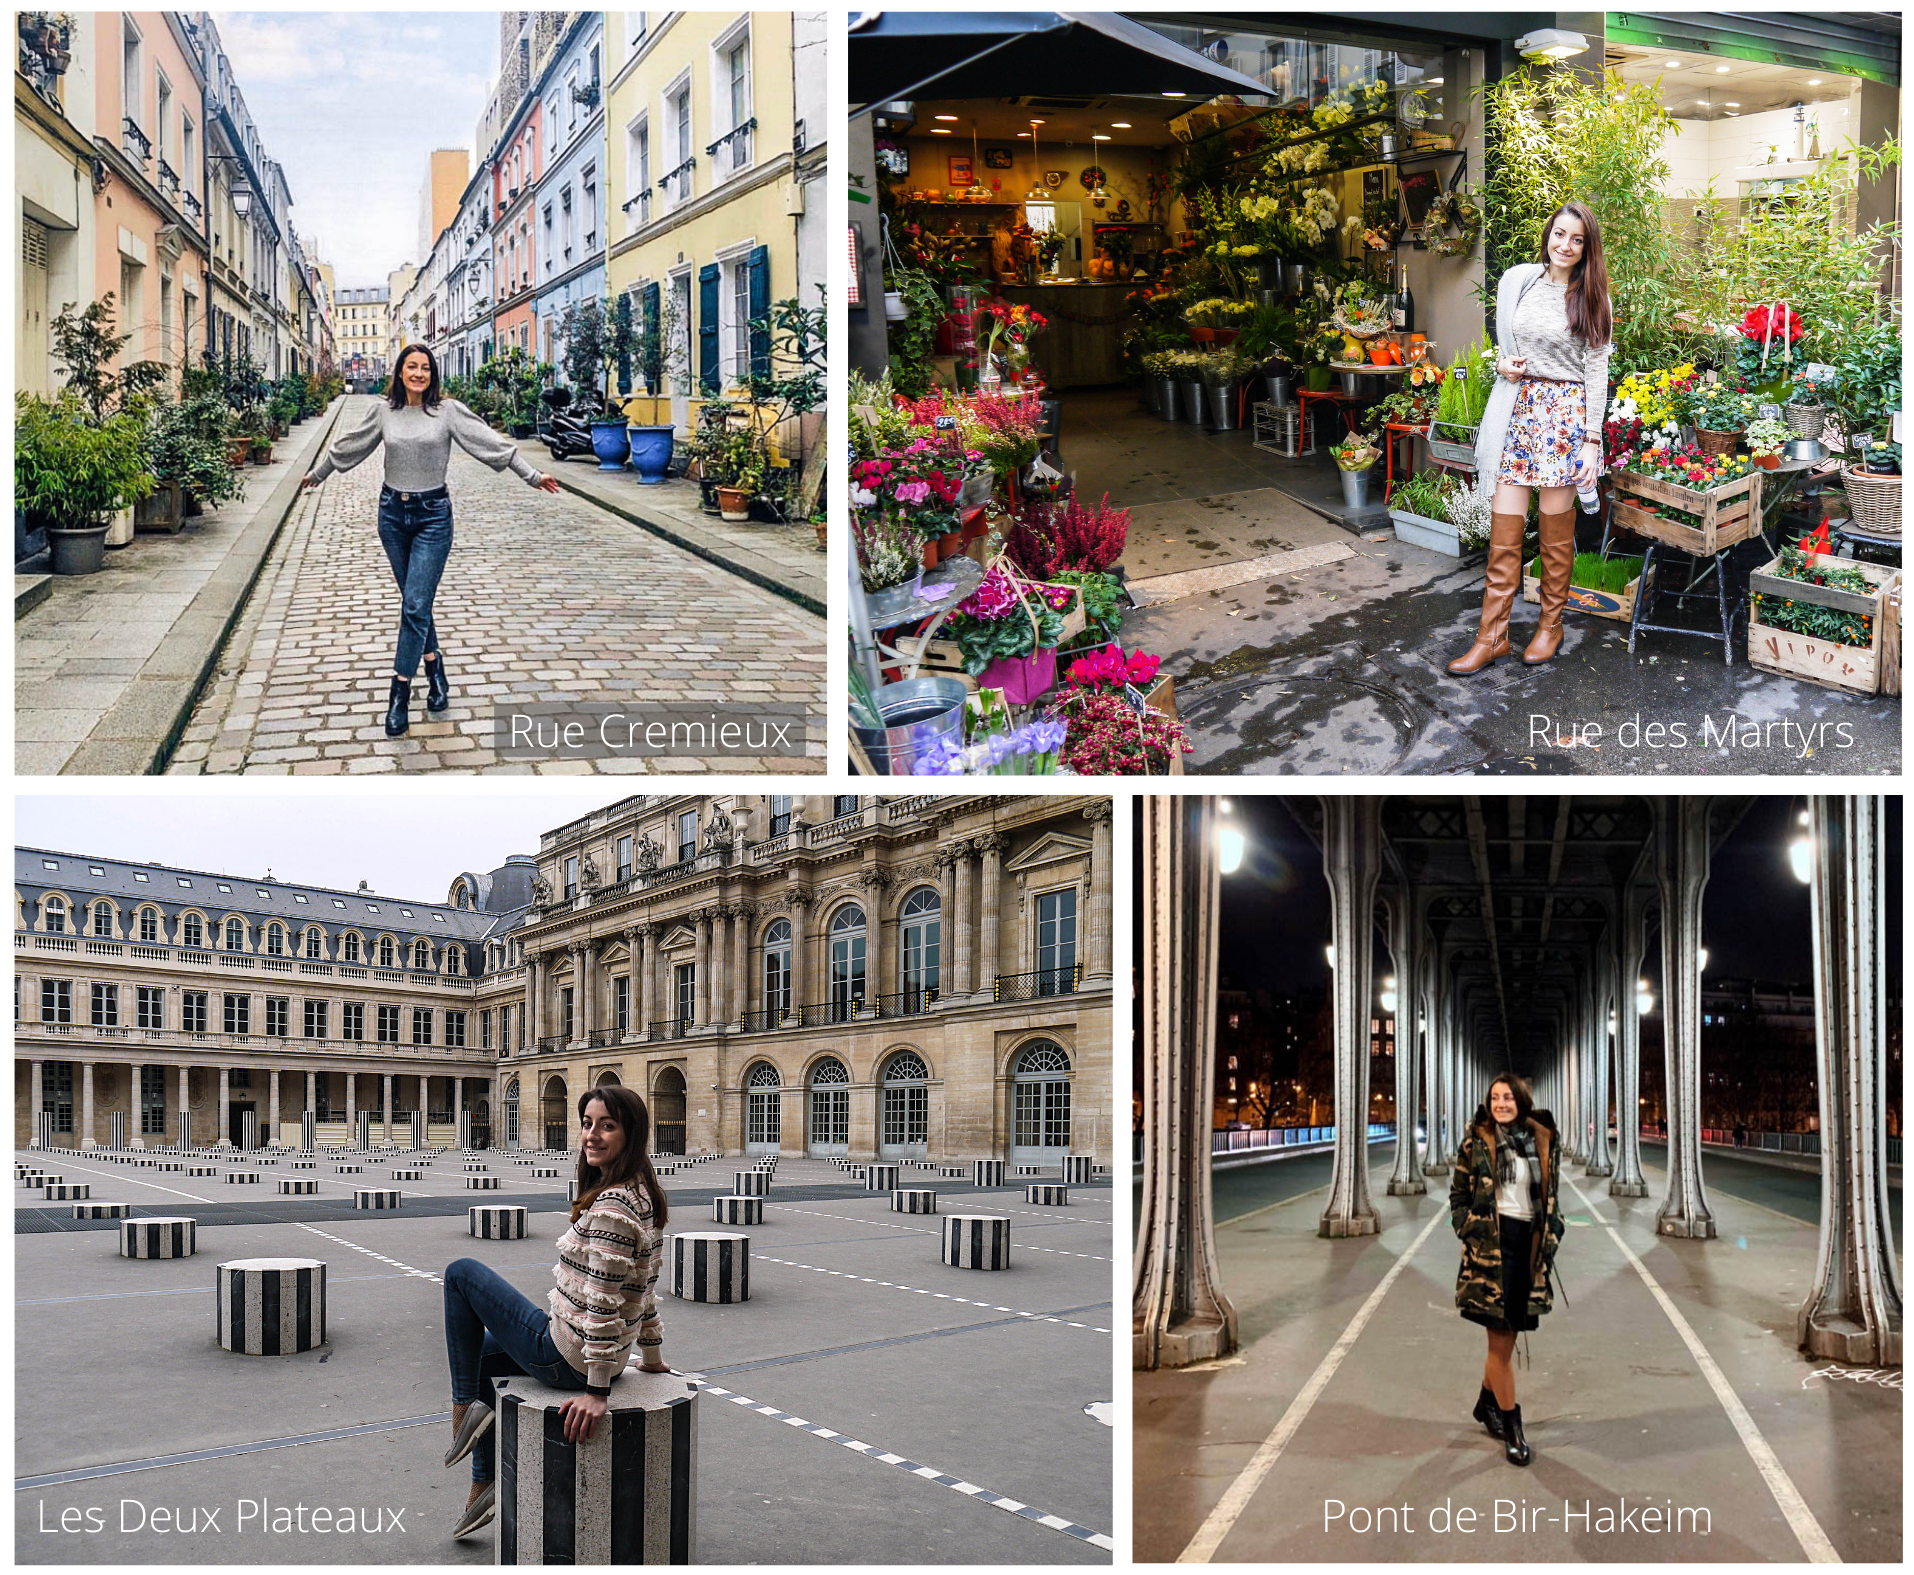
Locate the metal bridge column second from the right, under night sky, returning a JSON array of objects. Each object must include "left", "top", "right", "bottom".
[{"left": 1654, "top": 794, "right": 1715, "bottom": 1240}]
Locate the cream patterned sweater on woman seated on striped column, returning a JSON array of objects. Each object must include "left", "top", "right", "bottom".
[{"left": 547, "top": 1183, "right": 664, "bottom": 1393}]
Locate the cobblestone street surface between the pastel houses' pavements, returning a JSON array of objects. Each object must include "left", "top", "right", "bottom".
[{"left": 179, "top": 400, "right": 825, "bottom": 775}]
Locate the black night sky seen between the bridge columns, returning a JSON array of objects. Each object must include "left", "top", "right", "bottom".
[{"left": 1194, "top": 794, "right": 1901, "bottom": 993}]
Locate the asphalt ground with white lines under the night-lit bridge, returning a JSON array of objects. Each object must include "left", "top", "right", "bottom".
[{"left": 1133, "top": 1146, "right": 1901, "bottom": 1564}]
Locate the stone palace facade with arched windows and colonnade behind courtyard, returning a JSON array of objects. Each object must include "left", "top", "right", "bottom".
[{"left": 15, "top": 794, "right": 1112, "bottom": 1164}]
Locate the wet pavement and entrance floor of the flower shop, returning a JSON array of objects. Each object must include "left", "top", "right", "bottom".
[{"left": 1060, "top": 390, "right": 1901, "bottom": 775}]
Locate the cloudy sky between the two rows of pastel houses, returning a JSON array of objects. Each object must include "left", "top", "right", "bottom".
[{"left": 212, "top": 11, "right": 498, "bottom": 289}]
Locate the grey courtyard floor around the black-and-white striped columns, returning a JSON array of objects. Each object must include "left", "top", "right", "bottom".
[{"left": 15, "top": 1152, "right": 1116, "bottom": 1565}]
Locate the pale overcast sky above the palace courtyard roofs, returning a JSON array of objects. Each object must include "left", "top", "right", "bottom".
[{"left": 13, "top": 787, "right": 626, "bottom": 901}]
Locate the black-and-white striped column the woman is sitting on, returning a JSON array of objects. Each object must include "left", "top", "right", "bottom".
[{"left": 494, "top": 1368, "right": 699, "bottom": 1565}]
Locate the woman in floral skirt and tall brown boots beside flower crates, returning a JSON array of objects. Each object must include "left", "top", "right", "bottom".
[{"left": 1449, "top": 203, "right": 1614, "bottom": 674}]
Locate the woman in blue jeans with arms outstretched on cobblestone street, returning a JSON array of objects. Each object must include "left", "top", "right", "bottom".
[{"left": 300, "top": 344, "right": 559, "bottom": 739}]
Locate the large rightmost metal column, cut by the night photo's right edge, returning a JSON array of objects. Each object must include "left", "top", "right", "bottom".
[{"left": 1795, "top": 794, "right": 1901, "bottom": 1366}]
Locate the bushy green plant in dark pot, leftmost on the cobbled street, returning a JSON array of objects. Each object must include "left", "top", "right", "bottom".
[{"left": 13, "top": 390, "right": 153, "bottom": 574}]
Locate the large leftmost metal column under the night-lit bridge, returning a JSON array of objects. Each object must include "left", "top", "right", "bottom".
[{"left": 1129, "top": 796, "right": 1236, "bottom": 1368}]
